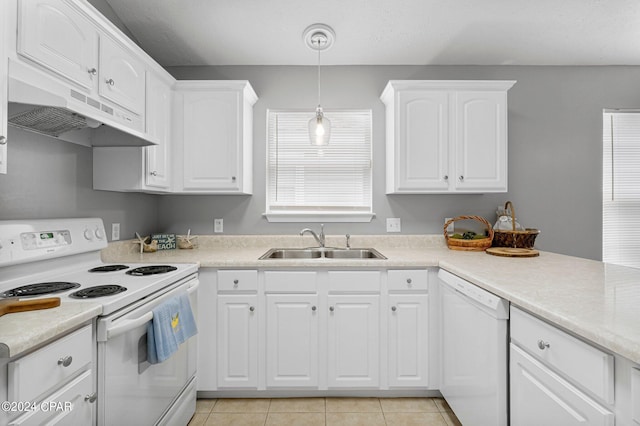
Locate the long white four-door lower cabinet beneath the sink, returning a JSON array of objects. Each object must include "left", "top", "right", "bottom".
[{"left": 198, "top": 268, "right": 430, "bottom": 397}]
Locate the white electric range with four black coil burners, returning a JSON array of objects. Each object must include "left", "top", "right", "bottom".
[{"left": 0, "top": 218, "right": 199, "bottom": 425}]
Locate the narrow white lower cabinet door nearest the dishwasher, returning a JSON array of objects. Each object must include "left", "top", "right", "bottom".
[{"left": 389, "top": 294, "right": 429, "bottom": 387}]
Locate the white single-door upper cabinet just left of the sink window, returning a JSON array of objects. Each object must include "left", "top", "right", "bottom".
[{"left": 174, "top": 81, "right": 258, "bottom": 194}]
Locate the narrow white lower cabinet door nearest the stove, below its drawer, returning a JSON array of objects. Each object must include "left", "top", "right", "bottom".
[{"left": 217, "top": 294, "right": 258, "bottom": 388}]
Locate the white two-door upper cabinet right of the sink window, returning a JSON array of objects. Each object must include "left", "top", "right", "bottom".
[{"left": 381, "top": 80, "right": 515, "bottom": 194}]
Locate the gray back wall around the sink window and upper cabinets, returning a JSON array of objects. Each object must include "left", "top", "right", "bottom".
[{"left": 159, "top": 66, "right": 640, "bottom": 259}]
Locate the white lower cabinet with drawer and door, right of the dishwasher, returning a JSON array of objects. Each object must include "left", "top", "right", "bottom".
[{"left": 509, "top": 306, "right": 625, "bottom": 426}]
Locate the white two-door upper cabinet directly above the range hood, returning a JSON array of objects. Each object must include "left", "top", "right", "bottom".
[{"left": 17, "top": 0, "right": 145, "bottom": 116}]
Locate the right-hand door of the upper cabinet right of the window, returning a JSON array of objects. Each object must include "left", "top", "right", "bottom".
[{"left": 451, "top": 91, "right": 507, "bottom": 192}]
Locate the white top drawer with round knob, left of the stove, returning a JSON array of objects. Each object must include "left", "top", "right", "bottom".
[{"left": 8, "top": 325, "right": 93, "bottom": 401}]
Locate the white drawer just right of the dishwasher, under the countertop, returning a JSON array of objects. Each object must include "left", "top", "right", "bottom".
[{"left": 511, "top": 306, "right": 614, "bottom": 404}]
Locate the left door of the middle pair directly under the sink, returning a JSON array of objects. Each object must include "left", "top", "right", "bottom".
[{"left": 267, "top": 294, "right": 318, "bottom": 387}]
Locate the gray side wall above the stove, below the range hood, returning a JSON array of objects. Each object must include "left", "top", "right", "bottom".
[{"left": 0, "top": 126, "right": 158, "bottom": 239}]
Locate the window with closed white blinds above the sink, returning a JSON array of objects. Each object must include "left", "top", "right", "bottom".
[{"left": 266, "top": 110, "right": 372, "bottom": 222}]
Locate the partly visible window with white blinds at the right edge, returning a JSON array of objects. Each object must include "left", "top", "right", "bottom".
[{"left": 602, "top": 111, "right": 640, "bottom": 268}]
